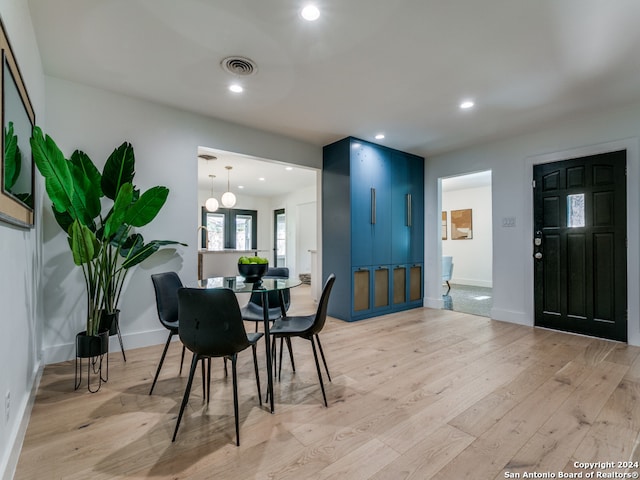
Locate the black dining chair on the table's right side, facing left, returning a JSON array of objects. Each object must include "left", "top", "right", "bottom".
[{"left": 270, "top": 273, "right": 336, "bottom": 407}]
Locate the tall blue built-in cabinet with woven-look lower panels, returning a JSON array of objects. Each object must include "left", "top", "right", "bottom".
[{"left": 322, "top": 137, "right": 424, "bottom": 321}]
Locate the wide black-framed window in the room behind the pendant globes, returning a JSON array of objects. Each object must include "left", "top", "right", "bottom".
[{"left": 202, "top": 207, "right": 258, "bottom": 250}]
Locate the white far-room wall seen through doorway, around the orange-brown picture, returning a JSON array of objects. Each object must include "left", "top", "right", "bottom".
[{"left": 442, "top": 186, "right": 493, "bottom": 287}]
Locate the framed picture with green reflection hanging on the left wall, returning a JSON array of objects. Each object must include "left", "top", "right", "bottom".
[{"left": 0, "top": 19, "right": 36, "bottom": 228}]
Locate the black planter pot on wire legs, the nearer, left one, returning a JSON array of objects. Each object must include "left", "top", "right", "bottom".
[{"left": 75, "top": 329, "right": 109, "bottom": 393}]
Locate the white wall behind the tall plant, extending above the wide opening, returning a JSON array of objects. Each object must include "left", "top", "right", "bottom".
[{"left": 43, "top": 77, "right": 322, "bottom": 363}]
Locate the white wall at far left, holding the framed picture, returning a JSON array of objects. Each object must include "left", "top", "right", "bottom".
[{"left": 0, "top": 0, "right": 45, "bottom": 478}]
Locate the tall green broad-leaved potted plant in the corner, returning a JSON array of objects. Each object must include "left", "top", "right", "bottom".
[{"left": 31, "top": 127, "right": 185, "bottom": 388}]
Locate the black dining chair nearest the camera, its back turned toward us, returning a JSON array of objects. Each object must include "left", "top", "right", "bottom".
[{"left": 172, "top": 288, "right": 263, "bottom": 445}]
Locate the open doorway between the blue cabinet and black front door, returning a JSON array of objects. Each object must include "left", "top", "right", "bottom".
[{"left": 440, "top": 170, "right": 492, "bottom": 317}]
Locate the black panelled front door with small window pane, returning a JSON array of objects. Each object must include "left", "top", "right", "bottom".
[{"left": 533, "top": 151, "right": 627, "bottom": 341}]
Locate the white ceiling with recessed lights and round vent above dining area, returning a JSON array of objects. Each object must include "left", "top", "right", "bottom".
[{"left": 28, "top": 0, "right": 640, "bottom": 195}]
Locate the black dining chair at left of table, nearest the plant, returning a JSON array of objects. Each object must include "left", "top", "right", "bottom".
[{"left": 149, "top": 272, "right": 185, "bottom": 395}]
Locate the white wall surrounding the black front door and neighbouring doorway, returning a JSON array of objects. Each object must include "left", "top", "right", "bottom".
[{"left": 425, "top": 104, "right": 640, "bottom": 345}]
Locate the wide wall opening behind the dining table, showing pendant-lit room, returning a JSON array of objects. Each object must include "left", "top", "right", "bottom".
[{"left": 194, "top": 146, "right": 319, "bottom": 277}]
